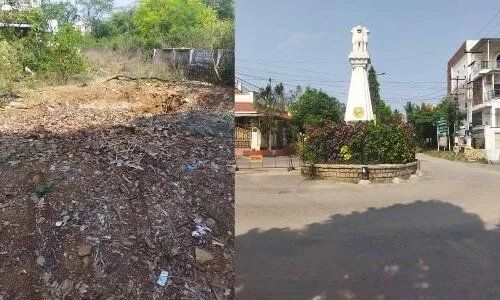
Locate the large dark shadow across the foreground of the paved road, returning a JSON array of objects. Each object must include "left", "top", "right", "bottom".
[{"left": 236, "top": 200, "right": 500, "bottom": 300}]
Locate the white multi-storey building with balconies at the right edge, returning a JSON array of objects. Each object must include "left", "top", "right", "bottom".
[{"left": 448, "top": 38, "right": 500, "bottom": 162}]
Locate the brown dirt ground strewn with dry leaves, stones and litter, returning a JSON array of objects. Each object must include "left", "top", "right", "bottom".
[{"left": 0, "top": 80, "right": 234, "bottom": 300}]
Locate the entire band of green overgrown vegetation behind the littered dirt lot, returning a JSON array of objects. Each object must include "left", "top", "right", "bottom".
[{"left": 0, "top": 0, "right": 234, "bottom": 92}]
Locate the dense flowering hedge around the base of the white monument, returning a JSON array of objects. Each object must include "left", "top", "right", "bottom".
[{"left": 298, "top": 122, "right": 416, "bottom": 164}]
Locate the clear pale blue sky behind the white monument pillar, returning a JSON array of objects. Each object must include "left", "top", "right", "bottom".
[{"left": 235, "top": 0, "right": 500, "bottom": 110}]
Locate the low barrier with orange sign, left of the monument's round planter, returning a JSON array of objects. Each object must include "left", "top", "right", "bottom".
[{"left": 236, "top": 155, "right": 302, "bottom": 170}]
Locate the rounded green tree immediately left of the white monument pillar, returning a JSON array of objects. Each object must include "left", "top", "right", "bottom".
[{"left": 290, "top": 87, "right": 345, "bottom": 133}]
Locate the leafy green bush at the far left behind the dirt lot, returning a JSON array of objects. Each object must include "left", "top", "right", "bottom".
[{"left": 0, "top": 9, "right": 88, "bottom": 91}]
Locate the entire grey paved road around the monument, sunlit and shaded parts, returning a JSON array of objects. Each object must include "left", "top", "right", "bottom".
[{"left": 236, "top": 156, "right": 500, "bottom": 300}]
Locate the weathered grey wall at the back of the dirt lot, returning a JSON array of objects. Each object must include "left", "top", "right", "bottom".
[{"left": 153, "top": 48, "right": 234, "bottom": 84}]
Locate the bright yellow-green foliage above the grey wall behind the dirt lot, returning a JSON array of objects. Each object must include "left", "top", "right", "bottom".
[{"left": 85, "top": 0, "right": 234, "bottom": 51}]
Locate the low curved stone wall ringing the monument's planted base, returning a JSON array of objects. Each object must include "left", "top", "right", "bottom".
[{"left": 301, "top": 161, "right": 418, "bottom": 183}]
